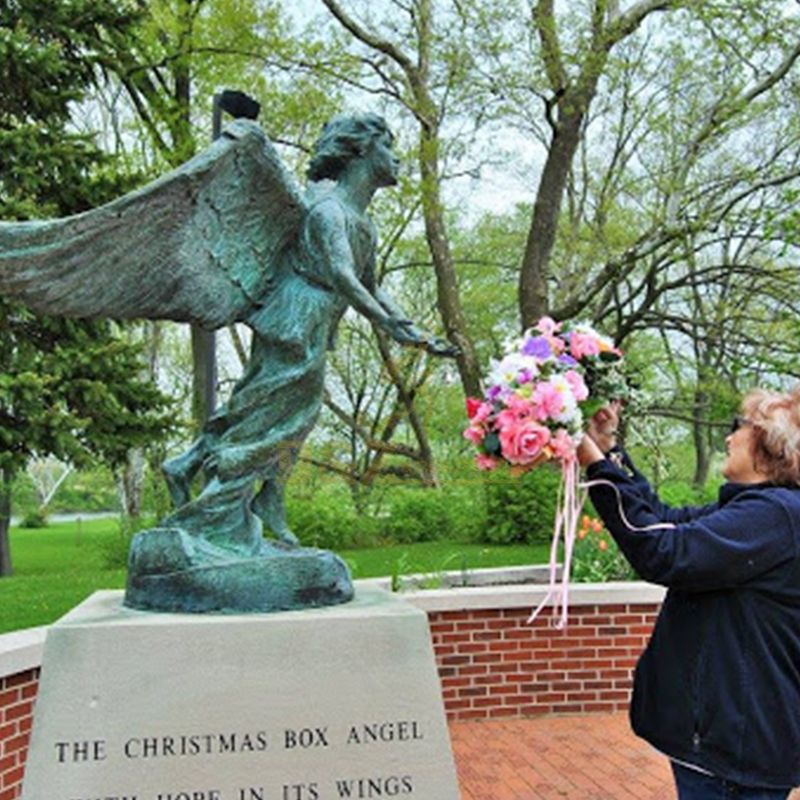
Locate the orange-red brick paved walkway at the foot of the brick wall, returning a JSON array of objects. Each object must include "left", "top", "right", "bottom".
[{"left": 450, "top": 713, "right": 800, "bottom": 800}]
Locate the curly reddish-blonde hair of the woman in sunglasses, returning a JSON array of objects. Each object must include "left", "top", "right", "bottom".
[{"left": 742, "top": 385, "right": 800, "bottom": 486}]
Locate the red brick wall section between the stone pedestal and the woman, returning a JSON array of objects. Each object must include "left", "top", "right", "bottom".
[{"left": 429, "top": 603, "right": 658, "bottom": 719}]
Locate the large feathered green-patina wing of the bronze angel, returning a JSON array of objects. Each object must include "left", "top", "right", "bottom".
[{"left": 0, "top": 120, "right": 305, "bottom": 328}]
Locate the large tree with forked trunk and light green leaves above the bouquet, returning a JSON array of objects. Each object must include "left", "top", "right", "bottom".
[{"left": 444, "top": 0, "right": 800, "bottom": 328}]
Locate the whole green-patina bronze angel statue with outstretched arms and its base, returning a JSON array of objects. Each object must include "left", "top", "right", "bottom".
[{"left": 0, "top": 114, "right": 455, "bottom": 612}]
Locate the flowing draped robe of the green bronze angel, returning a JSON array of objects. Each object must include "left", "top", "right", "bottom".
[{"left": 165, "top": 193, "right": 376, "bottom": 550}]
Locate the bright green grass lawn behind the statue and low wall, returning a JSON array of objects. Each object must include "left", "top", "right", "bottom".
[{"left": 0, "top": 518, "right": 549, "bottom": 633}]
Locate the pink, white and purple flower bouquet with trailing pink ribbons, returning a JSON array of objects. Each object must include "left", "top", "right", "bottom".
[{"left": 464, "top": 317, "right": 626, "bottom": 625}]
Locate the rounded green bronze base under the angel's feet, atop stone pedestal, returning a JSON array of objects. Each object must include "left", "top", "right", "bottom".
[{"left": 125, "top": 527, "right": 353, "bottom": 614}]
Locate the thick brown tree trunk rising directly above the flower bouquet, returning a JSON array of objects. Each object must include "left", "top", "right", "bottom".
[{"left": 519, "top": 111, "right": 584, "bottom": 330}]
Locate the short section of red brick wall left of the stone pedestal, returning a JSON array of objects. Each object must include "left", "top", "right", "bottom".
[{"left": 0, "top": 669, "right": 39, "bottom": 800}]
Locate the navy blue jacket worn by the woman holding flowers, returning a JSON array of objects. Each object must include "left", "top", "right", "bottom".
[{"left": 587, "top": 460, "right": 800, "bottom": 788}]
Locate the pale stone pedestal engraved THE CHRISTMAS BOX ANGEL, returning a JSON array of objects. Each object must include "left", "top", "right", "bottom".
[{"left": 23, "top": 589, "right": 458, "bottom": 800}]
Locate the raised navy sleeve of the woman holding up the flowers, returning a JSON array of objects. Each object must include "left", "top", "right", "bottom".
[{"left": 588, "top": 461, "right": 795, "bottom": 591}]
